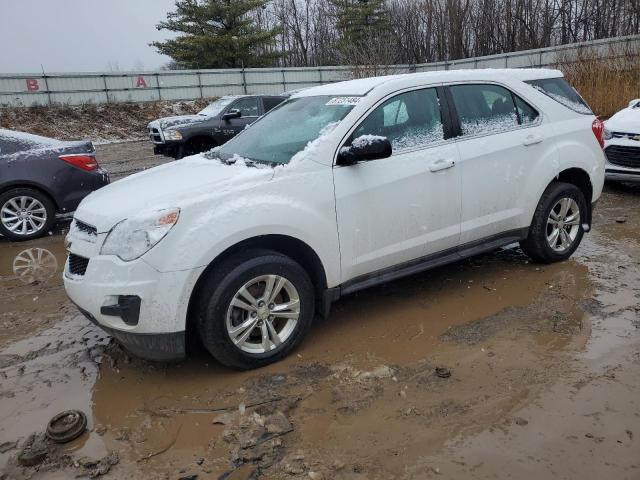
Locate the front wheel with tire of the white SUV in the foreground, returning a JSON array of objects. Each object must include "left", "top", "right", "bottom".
[{"left": 198, "top": 250, "right": 314, "bottom": 370}]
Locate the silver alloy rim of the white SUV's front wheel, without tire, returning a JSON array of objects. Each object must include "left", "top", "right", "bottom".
[{"left": 226, "top": 275, "right": 300, "bottom": 354}]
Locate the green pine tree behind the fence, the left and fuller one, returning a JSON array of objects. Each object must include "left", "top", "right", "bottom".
[{"left": 151, "top": 0, "right": 279, "bottom": 68}]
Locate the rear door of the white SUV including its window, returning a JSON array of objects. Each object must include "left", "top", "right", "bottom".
[{"left": 448, "top": 83, "right": 555, "bottom": 245}]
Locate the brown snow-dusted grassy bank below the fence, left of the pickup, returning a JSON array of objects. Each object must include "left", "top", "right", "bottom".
[{"left": 0, "top": 99, "right": 212, "bottom": 141}]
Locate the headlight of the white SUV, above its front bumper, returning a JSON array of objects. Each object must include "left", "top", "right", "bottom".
[{"left": 100, "top": 208, "right": 180, "bottom": 262}]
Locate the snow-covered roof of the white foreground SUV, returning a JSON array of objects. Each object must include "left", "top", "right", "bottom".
[{"left": 292, "top": 68, "right": 563, "bottom": 97}]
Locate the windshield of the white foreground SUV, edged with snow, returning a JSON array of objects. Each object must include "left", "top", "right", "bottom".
[{"left": 217, "top": 95, "right": 360, "bottom": 163}]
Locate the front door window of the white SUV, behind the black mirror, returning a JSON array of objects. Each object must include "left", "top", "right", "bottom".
[{"left": 353, "top": 88, "right": 444, "bottom": 152}]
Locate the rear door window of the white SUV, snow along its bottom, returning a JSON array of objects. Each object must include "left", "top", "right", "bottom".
[{"left": 450, "top": 84, "right": 520, "bottom": 135}]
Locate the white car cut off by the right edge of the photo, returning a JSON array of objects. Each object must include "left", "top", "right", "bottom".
[{"left": 604, "top": 98, "right": 640, "bottom": 182}]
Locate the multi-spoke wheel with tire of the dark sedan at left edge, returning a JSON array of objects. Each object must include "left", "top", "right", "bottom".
[{"left": 0, "top": 188, "right": 56, "bottom": 241}]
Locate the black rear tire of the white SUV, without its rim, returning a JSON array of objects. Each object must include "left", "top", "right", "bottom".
[{"left": 520, "top": 182, "right": 589, "bottom": 263}]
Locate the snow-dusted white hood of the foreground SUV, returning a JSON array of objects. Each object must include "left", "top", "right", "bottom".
[{"left": 75, "top": 155, "right": 274, "bottom": 233}]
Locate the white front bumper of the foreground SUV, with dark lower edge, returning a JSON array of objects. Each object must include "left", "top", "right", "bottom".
[{"left": 63, "top": 253, "right": 201, "bottom": 360}]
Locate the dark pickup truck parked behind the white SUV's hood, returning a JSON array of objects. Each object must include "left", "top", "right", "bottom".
[{"left": 147, "top": 95, "right": 286, "bottom": 159}]
